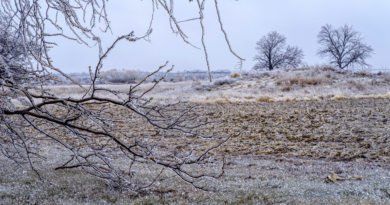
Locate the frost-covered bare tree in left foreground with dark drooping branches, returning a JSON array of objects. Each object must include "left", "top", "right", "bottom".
[{"left": 0, "top": 0, "right": 241, "bottom": 192}]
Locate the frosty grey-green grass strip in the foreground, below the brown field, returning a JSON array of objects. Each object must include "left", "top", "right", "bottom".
[{"left": 0, "top": 150, "right": 390, "bottom": 204}]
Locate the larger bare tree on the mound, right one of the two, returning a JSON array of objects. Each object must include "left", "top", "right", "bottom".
[{"left": 317, "top": 24, "right": 374, "bottom": 69}]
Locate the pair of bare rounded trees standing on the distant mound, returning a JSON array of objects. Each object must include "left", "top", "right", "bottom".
[{"left": 253, "top": 24, "right": 374, "bottom": 70}]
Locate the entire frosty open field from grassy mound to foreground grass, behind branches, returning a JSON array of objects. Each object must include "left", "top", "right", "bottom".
[{"left": 0, "top": 68, "right": 390, "bottom": 204}]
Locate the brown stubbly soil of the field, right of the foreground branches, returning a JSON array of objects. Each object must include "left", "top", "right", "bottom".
[{"left": 203, "top": 99, "right": 390, "bottom": 165}]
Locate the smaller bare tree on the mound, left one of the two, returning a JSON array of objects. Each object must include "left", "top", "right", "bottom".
[{"left": 254, "top": 31, "right": 304, "bottom": 70}]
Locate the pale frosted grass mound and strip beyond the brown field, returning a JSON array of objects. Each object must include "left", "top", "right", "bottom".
[{"left": 44, "top": 66, "right": 390, "bottom": 103}]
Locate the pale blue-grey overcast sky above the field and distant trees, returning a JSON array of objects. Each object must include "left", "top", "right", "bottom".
[{"left": 48, "top": 0, "right": 390, "bottom": 73}]
